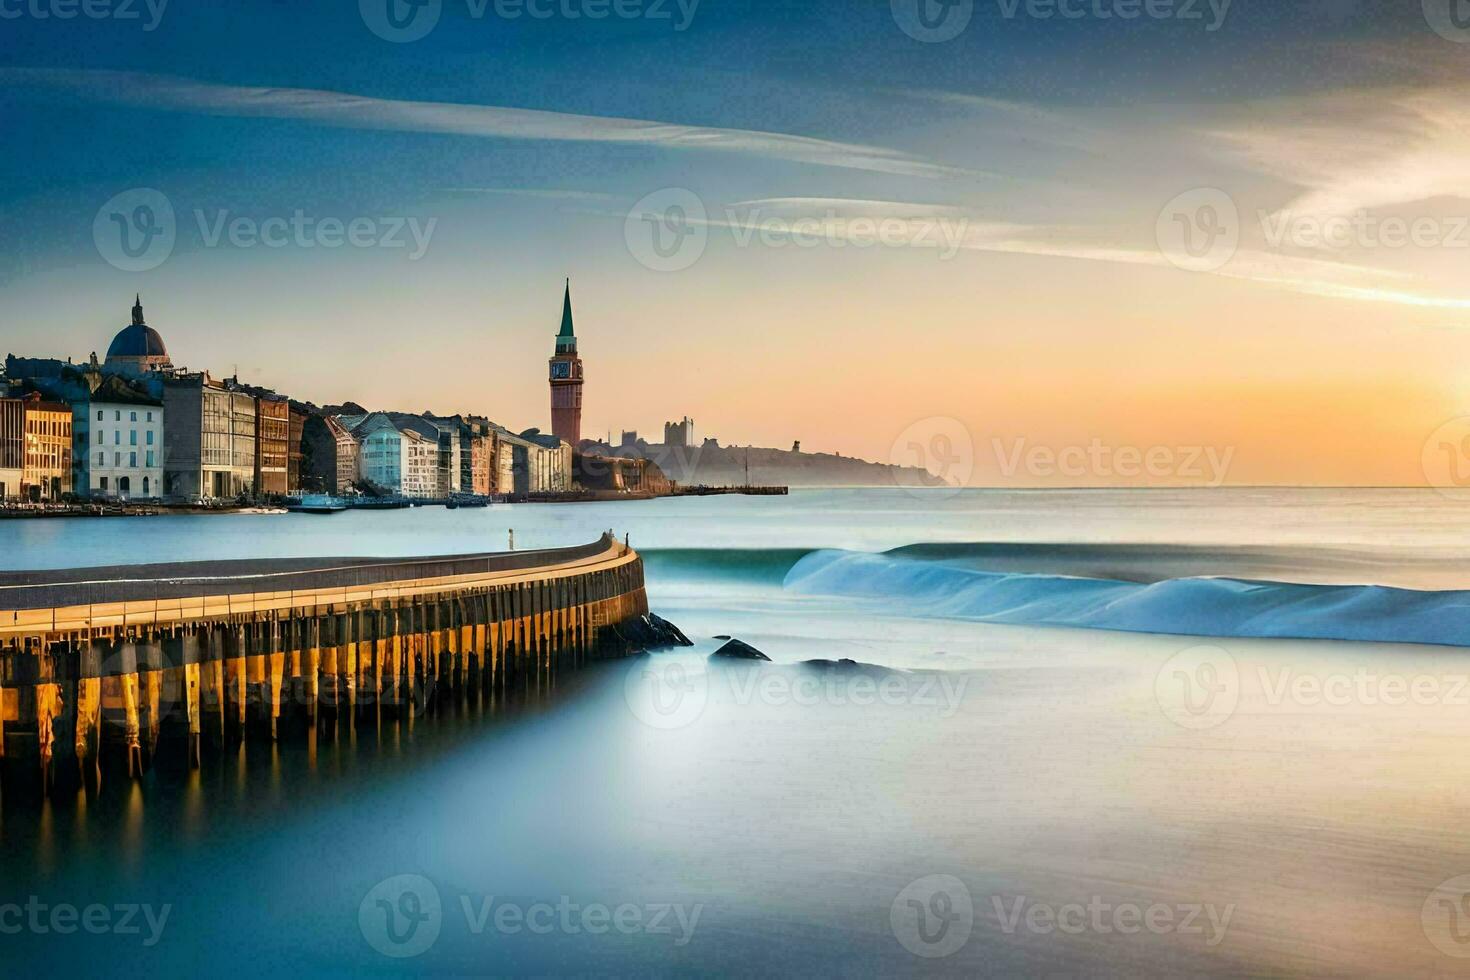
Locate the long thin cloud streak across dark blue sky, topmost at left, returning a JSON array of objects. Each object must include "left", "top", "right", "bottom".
[{"left": 0, "top": 68, "right": 982, "bottom": 179}]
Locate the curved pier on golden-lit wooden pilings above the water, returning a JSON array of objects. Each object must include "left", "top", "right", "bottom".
[{"left": 0, "top": 533, "right": 667, "bottom": 804}]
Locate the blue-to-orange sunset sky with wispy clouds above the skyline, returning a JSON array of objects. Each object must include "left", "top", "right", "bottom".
[{"left": 0, "top": 0, "right": 1470, "bottom": 486}]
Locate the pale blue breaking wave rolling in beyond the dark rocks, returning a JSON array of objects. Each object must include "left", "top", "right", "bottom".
[{"left": 784, "top": 545, "right": 1470, "bottom": 646}]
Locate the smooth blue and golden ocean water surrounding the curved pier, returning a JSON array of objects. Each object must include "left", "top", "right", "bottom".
[{"left": 0, "top": 489, "right": 1470, "bottom": 977}]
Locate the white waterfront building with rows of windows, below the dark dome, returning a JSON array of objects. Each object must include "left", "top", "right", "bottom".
[{"left": 72, "top": 375, "right": 165, "bottom": 500}]
